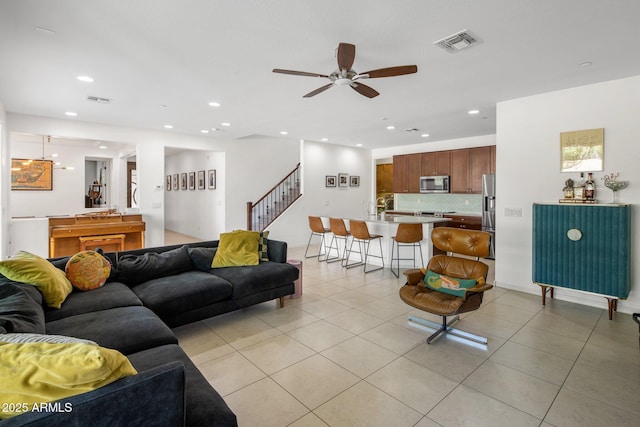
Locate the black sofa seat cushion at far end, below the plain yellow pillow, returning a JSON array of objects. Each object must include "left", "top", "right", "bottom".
[{"left": 210, "top": 261, "right": 299, "bottom": 299}]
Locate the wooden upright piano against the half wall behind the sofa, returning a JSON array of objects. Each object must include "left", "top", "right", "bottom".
[{"left": 49, "top": 213, "right": 145, "bottom": 258}]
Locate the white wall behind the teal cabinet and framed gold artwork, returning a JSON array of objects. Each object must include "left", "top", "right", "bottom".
[{"left": 496, "top": 76, "right": 640, "bottom": 313}]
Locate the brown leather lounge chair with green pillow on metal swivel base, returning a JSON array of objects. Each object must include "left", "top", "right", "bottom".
[{"left": 400, "top": 227, "right": 493, "bottom": 344}]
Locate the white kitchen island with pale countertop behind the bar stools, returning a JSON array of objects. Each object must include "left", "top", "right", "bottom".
[{"left": 332, "top": 214, "right": 449, "bottom": 268}]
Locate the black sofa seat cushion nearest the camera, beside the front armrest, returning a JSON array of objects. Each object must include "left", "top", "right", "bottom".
[{"left": 129, "top": 345, "right": 238, "bottom": 427}]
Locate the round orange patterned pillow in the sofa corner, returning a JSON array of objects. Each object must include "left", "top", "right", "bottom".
[{"left": 64, "top": 251, "right": 111, "bottom": 291}]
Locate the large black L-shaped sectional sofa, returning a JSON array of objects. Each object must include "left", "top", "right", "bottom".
[{"left": 0, "top": 240, "right": 299, "bottom": 427}]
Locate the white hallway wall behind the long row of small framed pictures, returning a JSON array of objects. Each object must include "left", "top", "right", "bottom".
[{"left": 164, "top": 150, "right": 225, "bottom": 240}]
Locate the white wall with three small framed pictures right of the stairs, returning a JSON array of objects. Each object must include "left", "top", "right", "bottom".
[{"left": 268, "top": 141, "right": 375, "bottom": 247}]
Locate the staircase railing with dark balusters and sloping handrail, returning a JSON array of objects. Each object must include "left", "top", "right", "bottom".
[{"left": 247, "top": 163, "right": 302, "bottom": 231}]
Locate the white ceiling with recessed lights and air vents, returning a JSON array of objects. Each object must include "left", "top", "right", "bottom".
[{"left": 0, "top": 0, "right": 640, "bottom": 148}]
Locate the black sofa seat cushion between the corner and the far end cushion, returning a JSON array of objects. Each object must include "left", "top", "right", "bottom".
[{"left": 133, "top": 271, "right": 233, "bottom": 319}]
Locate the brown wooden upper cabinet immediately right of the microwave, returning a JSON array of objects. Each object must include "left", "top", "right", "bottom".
[{"left": 451, "top": 147, "right": 495, "bottom": 193}]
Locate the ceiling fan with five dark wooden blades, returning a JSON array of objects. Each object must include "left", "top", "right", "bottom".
[{"left": 273, "top": 43, "right": 418, "bottom": 98}]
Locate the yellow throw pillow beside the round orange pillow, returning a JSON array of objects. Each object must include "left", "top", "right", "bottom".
[{"left": 0, "top": 251, "right": 73, "bottom": 308}]
